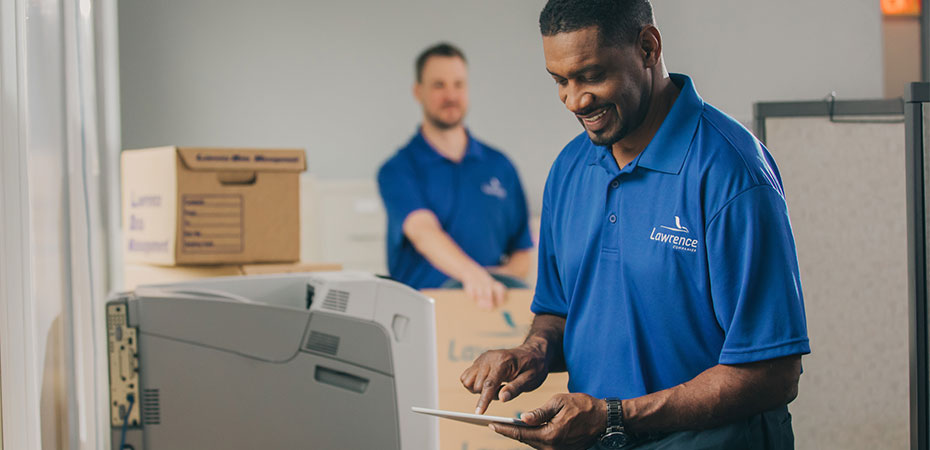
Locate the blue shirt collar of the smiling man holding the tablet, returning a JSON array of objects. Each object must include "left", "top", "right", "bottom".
[{"left": 590, "top": 73, "right": 704, "bottom": 174}]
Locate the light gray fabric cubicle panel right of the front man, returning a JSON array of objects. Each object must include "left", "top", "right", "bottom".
[{"left": 757, "top": 102, "right": 909, "bottom": 449}]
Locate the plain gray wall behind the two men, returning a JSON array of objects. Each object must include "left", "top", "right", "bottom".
[{"left": 119, "top": 0, "right": 882, "bottom": 212}]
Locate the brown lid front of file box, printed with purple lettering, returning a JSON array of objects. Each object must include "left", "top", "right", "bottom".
[{"left": 177, "top": 147, "right": 307, "bottom": 172}]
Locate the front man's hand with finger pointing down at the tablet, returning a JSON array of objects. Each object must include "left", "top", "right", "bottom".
[{"left": 459, "top": 344, "right": 549, "bottom": 414}]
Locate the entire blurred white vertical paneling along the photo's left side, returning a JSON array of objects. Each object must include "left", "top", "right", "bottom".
[{"left": 0, "top": 0, "right": 115, "bottom": 449}]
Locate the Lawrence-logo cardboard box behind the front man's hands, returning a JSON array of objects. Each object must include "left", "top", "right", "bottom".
[{"left": 423, "top": 289, "right": 568, "bottom": 450}]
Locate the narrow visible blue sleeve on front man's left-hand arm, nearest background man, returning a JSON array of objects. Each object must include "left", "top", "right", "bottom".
[{"left": 530, "top": 193, "right": 568, "bottom": 317}]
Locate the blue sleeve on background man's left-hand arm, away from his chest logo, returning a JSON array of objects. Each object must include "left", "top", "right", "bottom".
[{"left": 378, "top": 159, "right": 428, "bottom": 250}]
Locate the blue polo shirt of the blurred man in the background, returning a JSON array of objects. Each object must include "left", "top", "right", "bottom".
[{"left": 378, "top": 132, "right": 533, "bottom": 289}]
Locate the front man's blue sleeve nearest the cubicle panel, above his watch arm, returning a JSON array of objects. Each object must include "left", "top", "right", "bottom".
[{"left": 705, "top": 185, "right": 810, "bottom": 364}]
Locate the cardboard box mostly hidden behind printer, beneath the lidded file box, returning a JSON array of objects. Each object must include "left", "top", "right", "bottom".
[{"left": 123, "top": 263, "right": 342, "bottom": 290}]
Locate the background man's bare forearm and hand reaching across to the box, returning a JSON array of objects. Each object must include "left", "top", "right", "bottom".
[{"left": 402, "top": 209, "right": 507, "bottom": 308}]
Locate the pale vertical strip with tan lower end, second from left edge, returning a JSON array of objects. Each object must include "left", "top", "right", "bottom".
[{"left": 23, "top": 0, "right": 70, "bottom": 450}]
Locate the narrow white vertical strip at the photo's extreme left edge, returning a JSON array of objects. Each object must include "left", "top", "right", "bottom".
[{"left": 0, "top": 0, "right": 41, "bottom": 449}]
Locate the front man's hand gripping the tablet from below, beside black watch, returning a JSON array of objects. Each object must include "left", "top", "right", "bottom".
[{"left": 489, "top": 394, "right": 607, "bottom": 450}]
